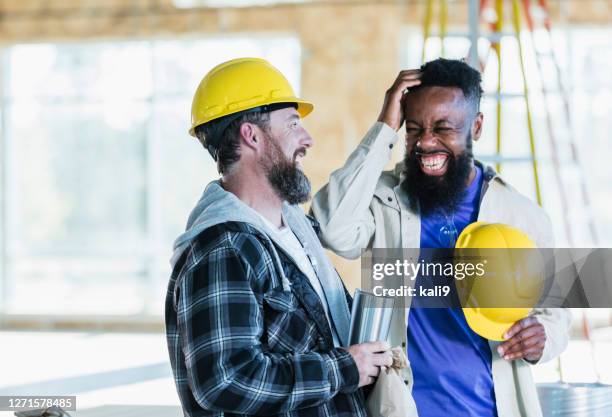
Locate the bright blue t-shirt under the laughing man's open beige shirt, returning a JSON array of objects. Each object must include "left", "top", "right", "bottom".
[{"left": 408, "top": 167, "right": 497, "bottom": 417}]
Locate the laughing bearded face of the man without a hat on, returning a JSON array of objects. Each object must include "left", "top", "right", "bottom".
[{"left": 401, "top": 86, "right": 483, "bottom": 215}]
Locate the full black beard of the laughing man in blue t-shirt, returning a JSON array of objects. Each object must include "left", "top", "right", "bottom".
[{"left": 400, "top": 145, "right": 472, "bottom": 215}]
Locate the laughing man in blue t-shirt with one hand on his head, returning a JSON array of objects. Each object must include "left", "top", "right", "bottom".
[{"left": 312, "top": 59, "right": 570, "bottom": 417}]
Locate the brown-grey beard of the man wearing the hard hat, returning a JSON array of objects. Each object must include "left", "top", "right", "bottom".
[{"left": 261, "top": 136, "right": 310, "bottom": 204}]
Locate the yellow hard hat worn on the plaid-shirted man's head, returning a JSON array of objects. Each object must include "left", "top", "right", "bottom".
[{"left": 189, "top": 58, "right": 313, "bottom": 136}]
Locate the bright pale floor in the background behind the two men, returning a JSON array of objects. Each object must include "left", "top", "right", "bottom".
[{"left": 0, "top": 331, "right": 612, "bottom": 417}]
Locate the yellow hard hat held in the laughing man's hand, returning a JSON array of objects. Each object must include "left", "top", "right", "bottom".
[{"left": 455, "top": 222, "right": 544, "bottom": 341}]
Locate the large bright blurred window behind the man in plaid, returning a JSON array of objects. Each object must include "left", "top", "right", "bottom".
[{"left": 0, "top": 35, "right": 301, "bottom": 315}]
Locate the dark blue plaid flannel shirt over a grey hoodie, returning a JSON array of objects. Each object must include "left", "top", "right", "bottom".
[{"left": 166, "top": 222, "right": 366, "bottom": 417}]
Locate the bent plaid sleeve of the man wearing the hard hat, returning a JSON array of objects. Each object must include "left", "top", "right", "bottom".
[{"left": 176, "top": 236, "right": 359, "bottom": 415}]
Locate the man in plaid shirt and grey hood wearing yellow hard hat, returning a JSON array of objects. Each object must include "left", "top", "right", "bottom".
[{"left": 166, "top": 58, "right": 392, "bottom": 417}]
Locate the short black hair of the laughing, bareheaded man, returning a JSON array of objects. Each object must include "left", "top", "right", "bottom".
[{"left": 411, "top": 58, "right": 483, "bottom": 112}]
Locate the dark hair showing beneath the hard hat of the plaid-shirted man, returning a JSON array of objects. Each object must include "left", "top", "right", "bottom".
[{"left": 194, "top": 111, "right": 270, "bottom": 175}]
